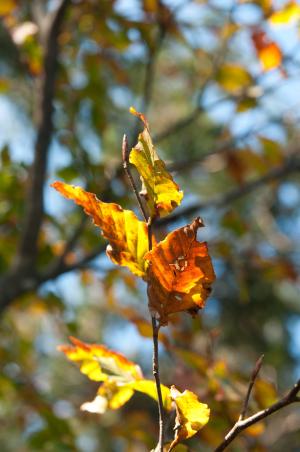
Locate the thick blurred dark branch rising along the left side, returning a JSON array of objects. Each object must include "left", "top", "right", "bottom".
[{"left": 0, "top": 0, "right": 69, "bottom": 311}]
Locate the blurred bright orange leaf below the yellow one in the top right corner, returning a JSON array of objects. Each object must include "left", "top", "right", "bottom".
[{"left": 252, "top": 30, "right": 282, "bottom": 71}]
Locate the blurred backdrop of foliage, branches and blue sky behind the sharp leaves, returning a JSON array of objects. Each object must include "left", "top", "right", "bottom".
[{"left": 0, "top": 0, "right": 300, "bottom": 452}]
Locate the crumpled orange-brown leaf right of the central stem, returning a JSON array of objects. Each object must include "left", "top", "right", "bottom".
[{"left": 145, "top": 218, "right": 215, "bottom": 325}]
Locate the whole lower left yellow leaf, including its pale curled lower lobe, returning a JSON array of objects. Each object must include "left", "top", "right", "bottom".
[{"left": 58, "top": 337, "right": 172, "bottom": 414}]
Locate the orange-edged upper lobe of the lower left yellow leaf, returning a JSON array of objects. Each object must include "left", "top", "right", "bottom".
[{"left": 58, "top": 337, "right": 143, "bottom": 382}]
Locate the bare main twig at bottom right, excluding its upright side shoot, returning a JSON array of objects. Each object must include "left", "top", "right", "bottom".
[{"left": 214, "top": 379, "right": 300, "bottom": 452}]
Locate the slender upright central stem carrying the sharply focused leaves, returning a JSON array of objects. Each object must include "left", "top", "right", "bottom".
[{"left": 122, "top": 135, "right": 164, "bottom": 452}]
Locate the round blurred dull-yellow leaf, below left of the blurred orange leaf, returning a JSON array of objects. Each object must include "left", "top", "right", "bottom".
[{"left": 216, "top": 63, "right": 252, "bottom": 94}]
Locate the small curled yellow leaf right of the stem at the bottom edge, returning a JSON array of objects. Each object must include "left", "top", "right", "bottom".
[{"left": 168, "top": 386, "right": 210, "bottom": 452}]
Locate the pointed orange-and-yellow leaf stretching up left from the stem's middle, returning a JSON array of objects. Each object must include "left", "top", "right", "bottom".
[{"left": 52, "top": 182, "right": 148, "bottom": 277}]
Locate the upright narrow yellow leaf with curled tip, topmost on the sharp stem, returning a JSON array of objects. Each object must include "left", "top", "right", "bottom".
[{"left": 129, "top": 107, "right": 183, "bottom": 218}]
